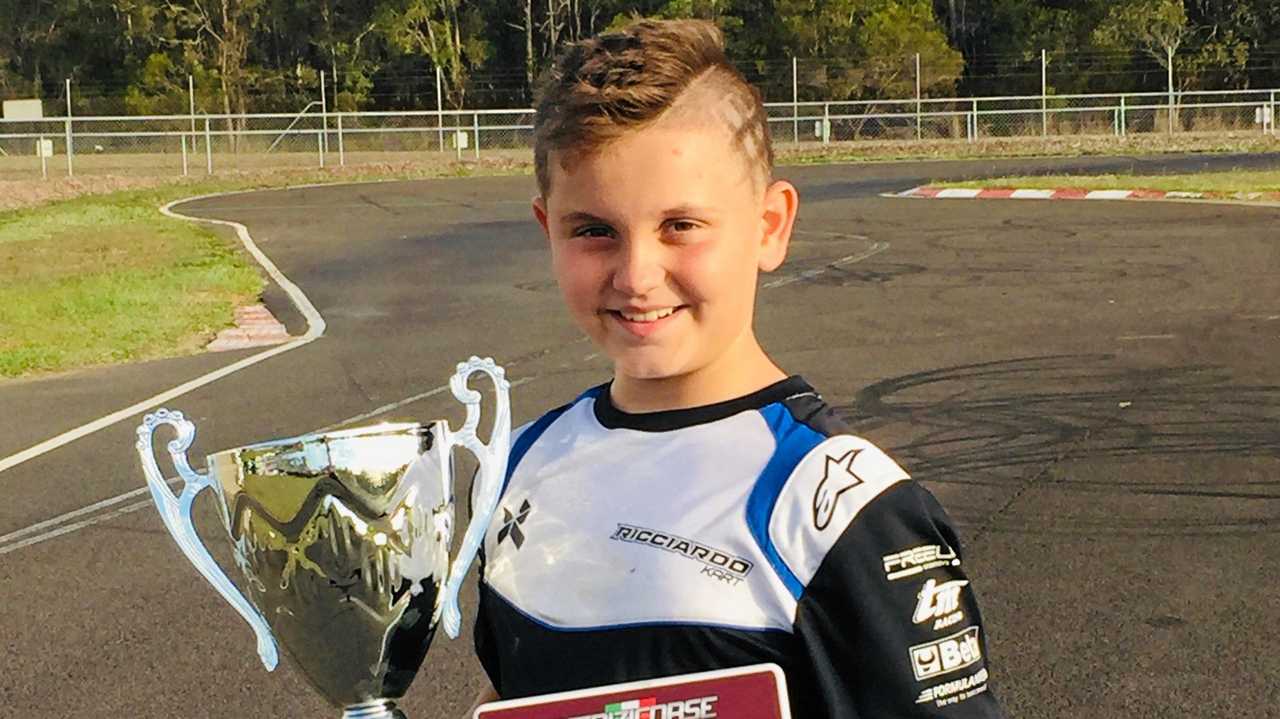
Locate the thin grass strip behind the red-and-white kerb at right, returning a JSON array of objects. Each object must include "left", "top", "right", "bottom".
[{"left": 929, "top": 170, "right": 1280, "bottom": 196}]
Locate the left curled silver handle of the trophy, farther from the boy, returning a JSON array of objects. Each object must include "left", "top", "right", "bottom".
[{"left": 137, "top": 409, "right": 280, "bottom": 672}]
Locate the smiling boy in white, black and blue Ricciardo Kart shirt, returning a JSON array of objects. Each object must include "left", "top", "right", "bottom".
[{"left": 475, "top": 20, "right": 1000, "bottom": 719}]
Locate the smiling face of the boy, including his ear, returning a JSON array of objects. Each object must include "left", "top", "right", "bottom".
[{"left": 534, "top": 118, "right": 796, "bottom": 380}]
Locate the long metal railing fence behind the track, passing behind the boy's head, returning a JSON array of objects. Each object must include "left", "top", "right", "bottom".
[{"left": 0, "top": 90, "right": 1280, "bottom": 179}]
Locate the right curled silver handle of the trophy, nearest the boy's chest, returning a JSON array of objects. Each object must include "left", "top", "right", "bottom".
[{"left": 443, "top": 357, "right": 511, "bottom": 638}]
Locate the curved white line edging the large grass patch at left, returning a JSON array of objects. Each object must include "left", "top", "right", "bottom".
[{"left": 0, "top": 193, "right": 325, "bottom": 472}]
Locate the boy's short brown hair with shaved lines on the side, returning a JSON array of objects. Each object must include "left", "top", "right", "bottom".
[{"left": 534, "top": 19, "right": 773, "bottom": 196}]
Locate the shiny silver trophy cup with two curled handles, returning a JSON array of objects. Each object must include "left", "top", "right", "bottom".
[{"left": 137, "top": 357, "right": 511, "bottom": 719}]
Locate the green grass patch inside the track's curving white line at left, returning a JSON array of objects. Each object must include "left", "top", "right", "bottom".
[{"left": 0, "top": 192, "right": 264, "bottom": 377}]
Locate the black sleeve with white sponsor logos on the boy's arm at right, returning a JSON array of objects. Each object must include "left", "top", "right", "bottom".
[{"left": 788, "top": 481, "right": 1002, "bottom": 719}]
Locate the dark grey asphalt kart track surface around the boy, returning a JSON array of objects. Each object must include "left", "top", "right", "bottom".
[{"left": 0, "top": 149, "right": 1280, "bottom": 718}]
